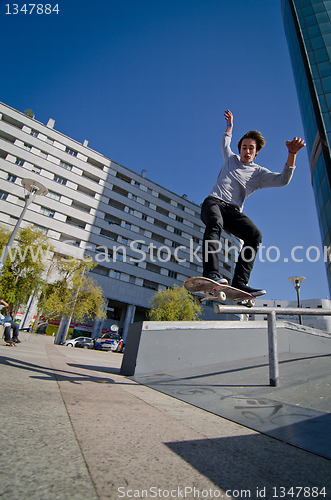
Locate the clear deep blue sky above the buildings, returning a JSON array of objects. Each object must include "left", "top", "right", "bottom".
[{"left": 0, "top": 0, "right": 329, "bottom": 300}]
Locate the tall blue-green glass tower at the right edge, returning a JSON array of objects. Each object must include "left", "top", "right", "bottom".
[{"left": 282, "top": 0, "right": 331, "bottom": 290}]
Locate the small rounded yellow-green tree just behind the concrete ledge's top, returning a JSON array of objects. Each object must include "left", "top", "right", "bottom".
[{"left": 148, "top": 285, "right": 201, "bottom": 321}]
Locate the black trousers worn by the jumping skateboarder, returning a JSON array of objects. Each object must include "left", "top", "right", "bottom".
[{"left": 201, "top": 196, "right": 262, "bottom": 286}]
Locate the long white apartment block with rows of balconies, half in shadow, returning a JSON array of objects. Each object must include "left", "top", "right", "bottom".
[{"left": 0, "top": 103, "right": 239, "bottom": 334}]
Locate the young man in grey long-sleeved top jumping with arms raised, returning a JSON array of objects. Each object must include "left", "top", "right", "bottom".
[{"left": 201, "top": 109, "right": 305, "bottom": 295}]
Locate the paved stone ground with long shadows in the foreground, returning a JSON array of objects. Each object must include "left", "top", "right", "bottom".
[{"left": 0, "top": 335, "right": 331, "bottom": 500}]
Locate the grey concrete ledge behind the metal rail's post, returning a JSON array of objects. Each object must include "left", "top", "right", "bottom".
[{"left": 121, "top": 321, "right": 331, "bottom": 376}]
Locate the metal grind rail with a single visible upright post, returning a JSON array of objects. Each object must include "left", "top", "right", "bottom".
[{"left": 214, "top": 304, "right": 331, "bottom": 387}]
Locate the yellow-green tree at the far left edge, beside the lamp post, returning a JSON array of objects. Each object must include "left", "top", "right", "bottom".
[{"left": 0, "top": 225, "right": 53, "bottom": 317}]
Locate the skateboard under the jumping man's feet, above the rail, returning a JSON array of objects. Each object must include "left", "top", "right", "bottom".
[{"left": 184, "top": 277, "right": 263, "bottom": 307}]
